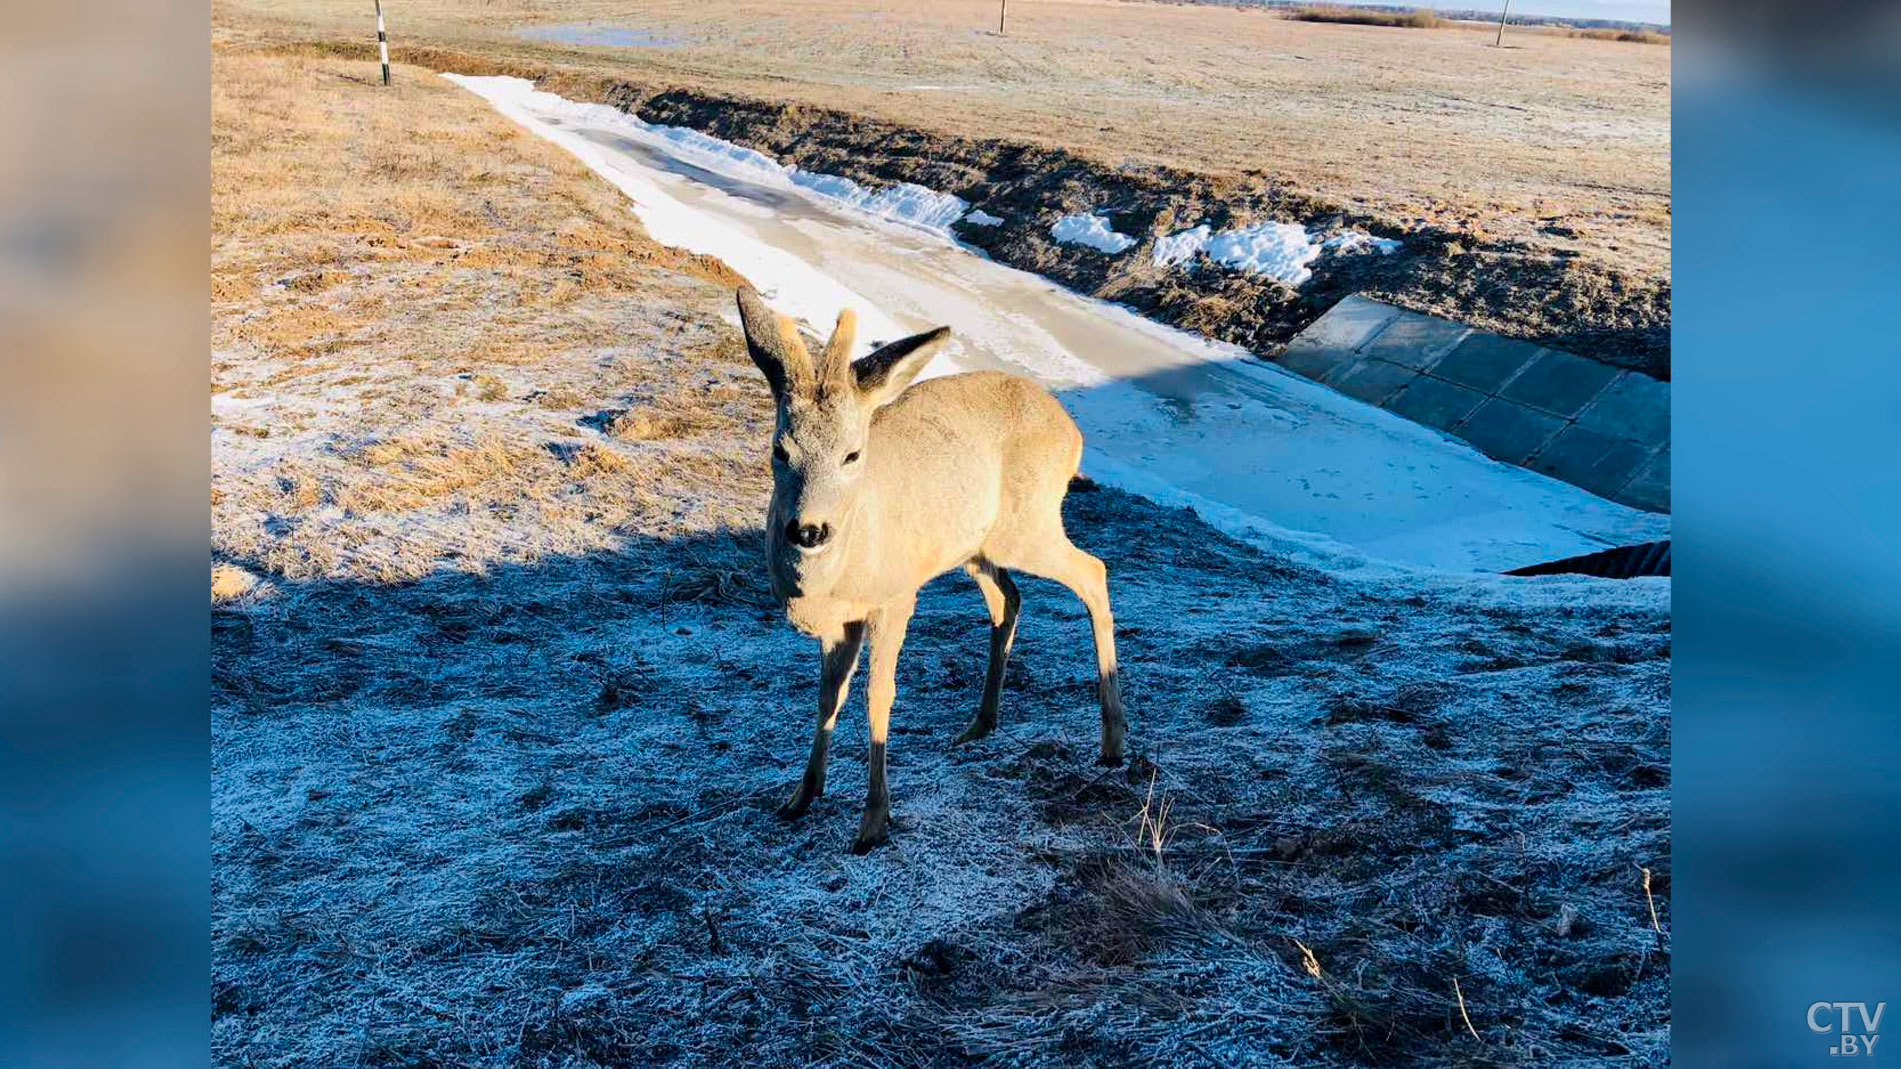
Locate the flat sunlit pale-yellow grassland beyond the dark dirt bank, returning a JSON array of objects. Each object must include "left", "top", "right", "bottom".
[{"left": 217, "top": 0, "right": 1671, "bottom": 276}]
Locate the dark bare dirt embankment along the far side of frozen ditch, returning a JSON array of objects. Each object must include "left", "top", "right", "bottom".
[{"left": 599, "top": 82, "right": 1671, "bottom": 379}]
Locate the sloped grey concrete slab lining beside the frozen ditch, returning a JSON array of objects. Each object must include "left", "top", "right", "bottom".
[{"left": 1279, "top": 289, "right": 1671, "bottom": 512}]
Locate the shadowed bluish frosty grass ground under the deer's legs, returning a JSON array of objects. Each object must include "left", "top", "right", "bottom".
[{"left": 213, "top": 489, "right": 1669, "bottom": 1065}]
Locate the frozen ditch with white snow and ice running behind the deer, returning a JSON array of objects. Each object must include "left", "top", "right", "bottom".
[{"left": 449, "top": 74, "right": 1669, "bottom": 571}]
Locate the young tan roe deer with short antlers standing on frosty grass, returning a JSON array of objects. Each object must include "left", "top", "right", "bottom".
[{"left": 739, "top": 287, "right": 1127, "bottom": 854}]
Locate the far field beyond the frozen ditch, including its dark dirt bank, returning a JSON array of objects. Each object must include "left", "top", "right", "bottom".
[{"left": 219, "top": 0, "right": 1671, "bottom": 377}]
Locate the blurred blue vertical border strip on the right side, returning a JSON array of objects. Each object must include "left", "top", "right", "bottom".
[{"left": 1671, "top": 2, "right": 1901, "bottom": 1067}]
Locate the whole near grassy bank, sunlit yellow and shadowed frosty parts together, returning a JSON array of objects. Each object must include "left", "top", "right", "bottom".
[{"left": 211, "top": 43, "right": 1671, "bottom": 1067}]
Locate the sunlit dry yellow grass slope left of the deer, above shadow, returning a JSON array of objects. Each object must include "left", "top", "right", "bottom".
[{"left": 211, "top": 46, "right": 764, "bottom": 582}]
